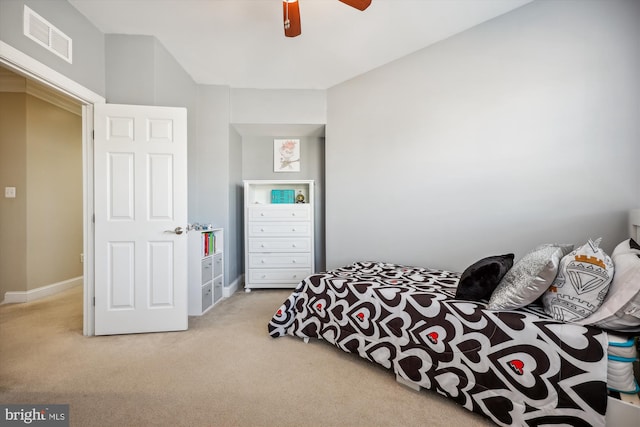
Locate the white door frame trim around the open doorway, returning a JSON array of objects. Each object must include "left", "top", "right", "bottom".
[{"left": 0, "top": 40, "right": 106, "bottom": 336}]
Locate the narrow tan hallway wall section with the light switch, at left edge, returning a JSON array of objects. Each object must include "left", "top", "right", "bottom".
[{"left": 0, "top": 92, "right": 27, "bottom": 301}]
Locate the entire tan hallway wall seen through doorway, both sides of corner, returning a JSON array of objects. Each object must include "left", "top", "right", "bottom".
[{"left": 0, "top": 87, "right": 83, "bottom": 301}]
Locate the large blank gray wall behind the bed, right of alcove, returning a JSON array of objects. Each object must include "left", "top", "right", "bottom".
[{"left": 326, "top": 0, "right": 640, "bottom": 271}]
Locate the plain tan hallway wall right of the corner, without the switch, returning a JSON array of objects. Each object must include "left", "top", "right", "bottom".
[{"left": 26, "top": 95, "right": 82, "bottom": 290}]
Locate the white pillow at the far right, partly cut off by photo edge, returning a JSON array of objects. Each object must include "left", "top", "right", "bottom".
[{"left": 578, "top": 239, "right": 640, "bottom": 332}]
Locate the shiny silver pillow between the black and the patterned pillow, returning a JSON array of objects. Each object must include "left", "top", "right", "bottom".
[{"left": 487, "top": 243, "right": 573, "bottom": 310}]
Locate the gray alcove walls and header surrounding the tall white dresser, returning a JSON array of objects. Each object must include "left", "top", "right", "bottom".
[{"left": 229, "top": 88, "right": 327, "bottom": 272}]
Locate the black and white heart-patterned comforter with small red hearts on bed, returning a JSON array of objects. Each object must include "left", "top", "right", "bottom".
[{"left": 269, "top": 262, "right": 607, "bottom": 426}]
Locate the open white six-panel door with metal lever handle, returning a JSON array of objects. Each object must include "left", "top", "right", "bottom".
[{"left": 94, "top": 104, "right": 188, "bottom": 335}]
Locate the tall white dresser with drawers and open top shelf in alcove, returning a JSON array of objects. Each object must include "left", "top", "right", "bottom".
[{"left": 244, "top": 180, "right": 314, "bottom": 292}]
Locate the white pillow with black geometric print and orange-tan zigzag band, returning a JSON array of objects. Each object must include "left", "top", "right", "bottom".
[{"left": 542, "top": 239, "right": 614, "bottom": 322}]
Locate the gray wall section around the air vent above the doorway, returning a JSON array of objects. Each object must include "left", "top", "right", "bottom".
[{"left": 0, "top": 0, "right": 105, "bottom": 96}]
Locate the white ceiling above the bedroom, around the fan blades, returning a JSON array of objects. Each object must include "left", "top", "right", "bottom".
[{"left": 69, "top": 0, "right": 532, "bottom": 89}]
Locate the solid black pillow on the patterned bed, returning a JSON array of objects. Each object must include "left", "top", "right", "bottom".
[{"left": 456, "top": 254, "right": 514, "bottom": 301}]
